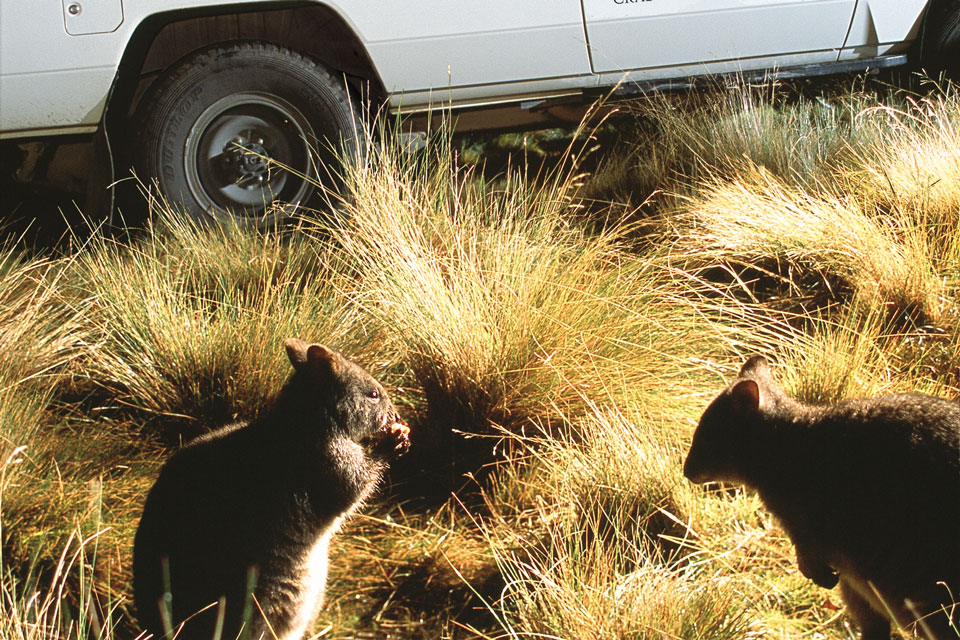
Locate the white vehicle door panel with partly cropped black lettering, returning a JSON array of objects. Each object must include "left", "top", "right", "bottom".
[{"left": 583, "top": 0, "right": 856, "bottom": 75}]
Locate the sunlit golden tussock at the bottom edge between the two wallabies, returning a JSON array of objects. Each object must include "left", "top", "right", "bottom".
[{"left": 492, "top": 539, "right": 750, "bottom": 640}]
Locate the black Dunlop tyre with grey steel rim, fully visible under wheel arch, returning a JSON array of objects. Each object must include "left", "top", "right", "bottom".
[{"left": 133, "top": 41, "right": 362, "bottom": 227}]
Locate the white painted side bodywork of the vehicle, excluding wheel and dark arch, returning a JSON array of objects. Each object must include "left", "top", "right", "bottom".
[{"left": 0, "top": 0, "right": 927, "bottom": 137}]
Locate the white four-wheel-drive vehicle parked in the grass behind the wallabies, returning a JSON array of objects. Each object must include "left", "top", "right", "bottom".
[{"left": 0, "top": 0, "right": 960, "bottom": 221}]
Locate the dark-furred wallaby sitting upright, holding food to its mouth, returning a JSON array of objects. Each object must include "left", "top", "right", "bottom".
[{"left": 133, "top": 340, "right": 409, "bottom": 640}]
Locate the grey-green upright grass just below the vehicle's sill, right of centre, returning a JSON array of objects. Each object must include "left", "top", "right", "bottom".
[{"left": 586, "top": 82, "right": 876, "bottom": 209}]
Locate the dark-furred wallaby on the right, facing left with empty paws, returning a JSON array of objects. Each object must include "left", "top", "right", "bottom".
[{"left": 684, "top": 357, "right": 960, "bottom": 640}]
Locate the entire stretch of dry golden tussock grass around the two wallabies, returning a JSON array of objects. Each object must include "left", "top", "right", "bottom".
[{"left": 0, "top": 80, "right": 960, "bottom": 640}]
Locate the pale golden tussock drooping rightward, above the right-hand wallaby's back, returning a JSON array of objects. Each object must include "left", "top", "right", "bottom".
[{"left": 674, "top": 171, "right": 945, "bottom": 324}]
